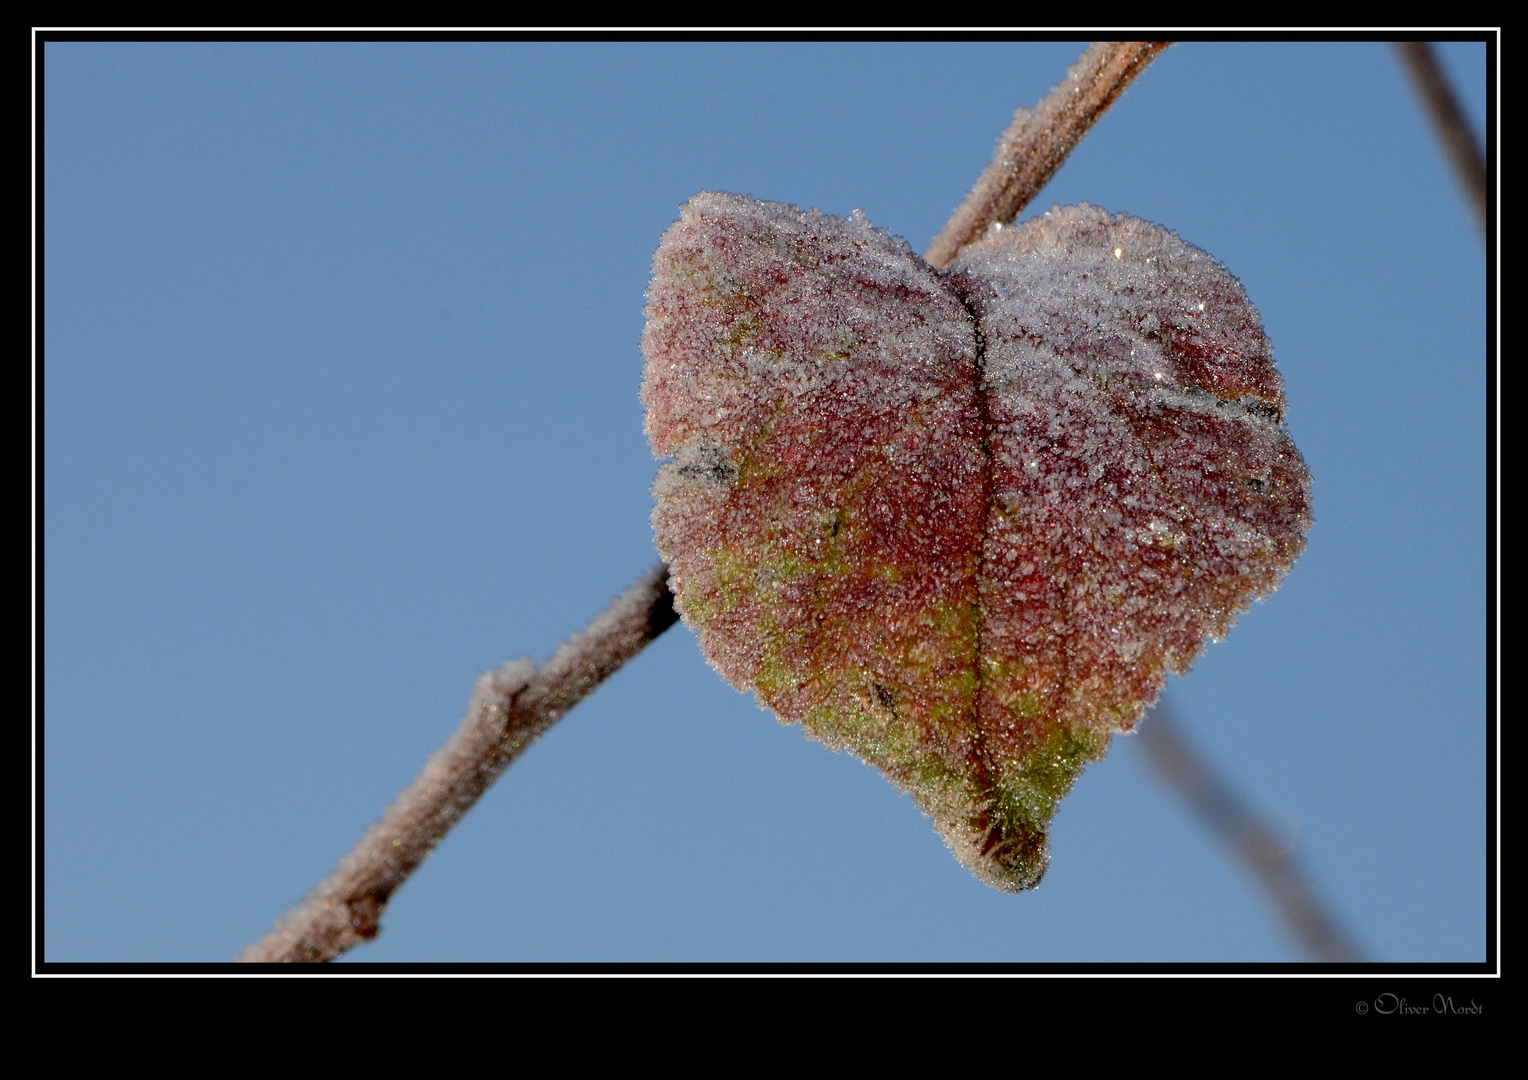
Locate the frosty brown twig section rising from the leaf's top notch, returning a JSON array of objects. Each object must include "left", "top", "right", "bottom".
[{"left": 923, "top": 41, "right": 1170, "bottom": 269}]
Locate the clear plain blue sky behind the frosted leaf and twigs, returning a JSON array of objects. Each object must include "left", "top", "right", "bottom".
[{"left": 41, "top": 43, "right": 1490, "bottom": 962}]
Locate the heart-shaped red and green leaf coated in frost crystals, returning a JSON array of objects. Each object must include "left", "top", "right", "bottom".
[{"left": 642, "top": 192, "right": 1309, "bottom": 889}]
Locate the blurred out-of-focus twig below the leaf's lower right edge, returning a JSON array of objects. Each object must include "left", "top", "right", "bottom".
[{"left": 1140, "top": 704, "right": 1361, "bottom": 964}]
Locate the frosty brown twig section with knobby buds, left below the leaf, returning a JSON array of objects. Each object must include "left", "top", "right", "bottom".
[{"left": 238, "top": 565, "right": 678, "bottom": 962}]
